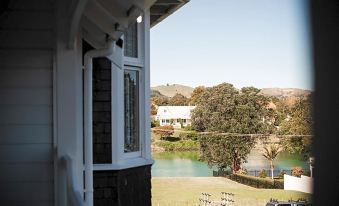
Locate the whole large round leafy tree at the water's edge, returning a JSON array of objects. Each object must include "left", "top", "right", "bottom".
[{"left": 192, "top": 83, "right": 274, "bottom": 172}]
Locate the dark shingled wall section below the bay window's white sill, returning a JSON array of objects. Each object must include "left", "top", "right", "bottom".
[{"left": 94, "top": 165, "right": 151, "bottom": 206}]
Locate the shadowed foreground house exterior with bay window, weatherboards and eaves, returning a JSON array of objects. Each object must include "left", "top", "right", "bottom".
[{"left": 0, "top": 0, "right": 187, "bottom": 206}]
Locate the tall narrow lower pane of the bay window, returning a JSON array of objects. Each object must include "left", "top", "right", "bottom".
[{"left": 124, "top": 70, "right": 139, "bottom": 152}]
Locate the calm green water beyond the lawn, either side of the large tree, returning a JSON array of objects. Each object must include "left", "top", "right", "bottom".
[{"left": 152, "top": 149, "right": 309, "bottom": 177}]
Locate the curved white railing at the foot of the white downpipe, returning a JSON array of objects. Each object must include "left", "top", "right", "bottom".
[{"left": 61, "top": 155, "right": 85, "bottom": 206}]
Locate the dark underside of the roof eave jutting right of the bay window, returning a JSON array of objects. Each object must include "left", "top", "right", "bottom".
[{"left": 150, "top": 0, "right": 189, "bottom": 27}]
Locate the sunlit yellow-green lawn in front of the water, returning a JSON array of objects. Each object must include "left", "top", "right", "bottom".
[{"left": 152, "top": 177, "right": 311, "bottom": 206}]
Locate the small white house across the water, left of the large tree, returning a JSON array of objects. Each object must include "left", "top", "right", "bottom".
[{"left": 156, "top": 106, "right": 195, "bottom": 128}]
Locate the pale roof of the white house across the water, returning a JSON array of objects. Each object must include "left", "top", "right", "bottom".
[{"left": 157, "top": 106, "right": 195, "bottom": 119}]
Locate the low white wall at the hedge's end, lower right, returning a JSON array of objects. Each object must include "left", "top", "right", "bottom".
[{"left": 284, "top": 174, "right": 313, "bottom": 193}]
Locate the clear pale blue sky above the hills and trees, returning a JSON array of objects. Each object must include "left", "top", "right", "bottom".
[{"left": 151, "top": 0, "right": 313, "bottom": 89}]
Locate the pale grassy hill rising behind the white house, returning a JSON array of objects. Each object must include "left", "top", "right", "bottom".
[{"left": 151, "top": 84, "right": 194, "bottom": 97}]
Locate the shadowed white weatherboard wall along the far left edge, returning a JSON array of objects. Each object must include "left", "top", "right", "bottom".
[{"left": 0, "top": 0, "right": 54, "bottom": 205}]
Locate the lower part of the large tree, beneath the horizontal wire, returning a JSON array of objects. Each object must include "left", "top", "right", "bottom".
[{"left": 199, "top": 133, "right": 256, "bottom": 173}]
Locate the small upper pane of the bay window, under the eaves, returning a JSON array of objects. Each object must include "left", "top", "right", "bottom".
[{"left": 124, "top": 23, "right": 138, "bottom": 58}]
